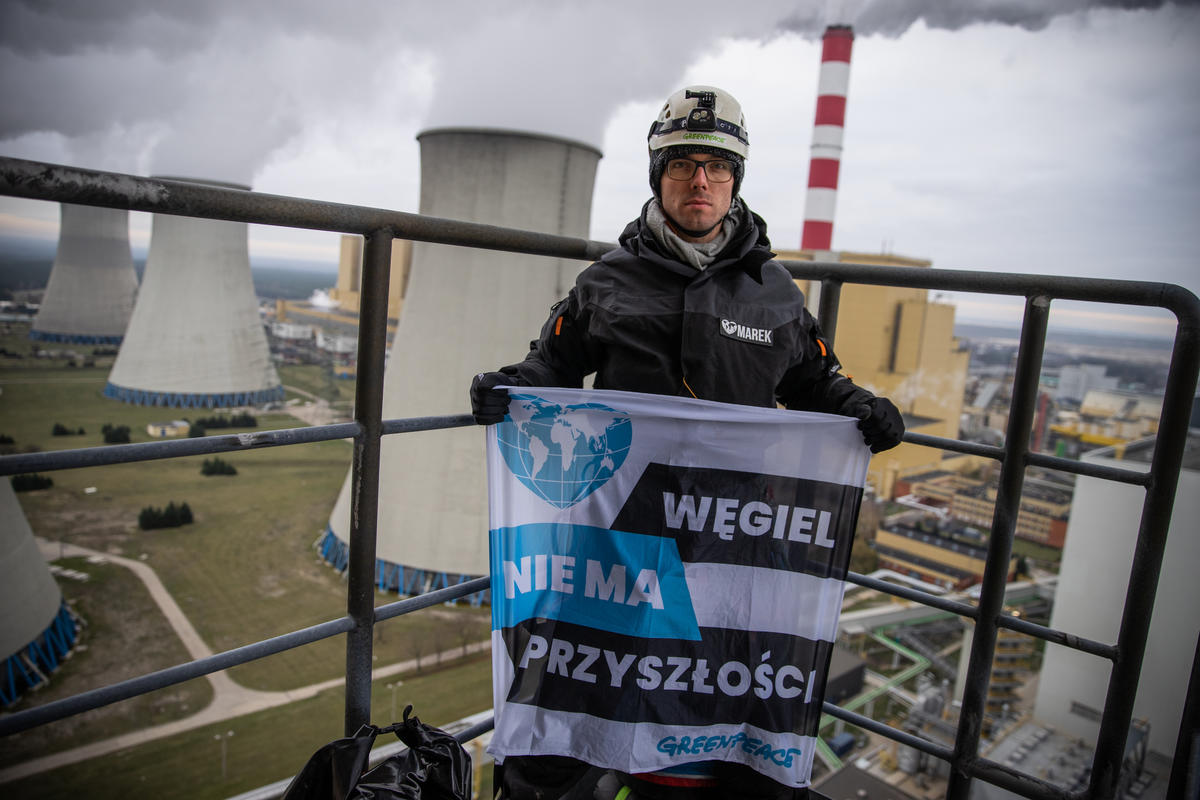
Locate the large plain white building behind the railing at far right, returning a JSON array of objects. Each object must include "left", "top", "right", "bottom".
[{"left": 1034, "top": 429, "right": 1200, "bottom": 757}]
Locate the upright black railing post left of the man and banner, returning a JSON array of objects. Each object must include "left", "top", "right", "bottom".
[{"left": 346, "top": 228, "right": 392, "bottom": 736}]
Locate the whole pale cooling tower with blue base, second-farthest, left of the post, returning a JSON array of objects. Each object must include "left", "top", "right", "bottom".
[{"left": 104, "top": 179, "right": 283, "bottom": 408}]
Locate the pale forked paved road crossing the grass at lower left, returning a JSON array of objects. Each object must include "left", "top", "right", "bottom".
[{"left": 0, "top": 537, "right": 491, "bottom": 783}]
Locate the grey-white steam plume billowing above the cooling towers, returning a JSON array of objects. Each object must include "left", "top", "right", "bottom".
[{"left": 0, "top": 0, "right": 1194, "bottom": 185}]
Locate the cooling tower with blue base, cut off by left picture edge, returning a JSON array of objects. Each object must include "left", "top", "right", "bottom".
[{"left": 0, "top": 479, "right": 77, "bottom": 705}]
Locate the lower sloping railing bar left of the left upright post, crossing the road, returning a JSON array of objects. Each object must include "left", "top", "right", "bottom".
[{"left": 0, "top": 616, "right": 354, "bottom": 736}]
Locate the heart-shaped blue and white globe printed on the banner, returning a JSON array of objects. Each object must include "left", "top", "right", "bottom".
[{"left": 496, "top": 393, "right": 634, "bottom": 509}]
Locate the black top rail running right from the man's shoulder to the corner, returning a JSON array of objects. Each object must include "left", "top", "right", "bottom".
[{"left": 778, "top": 259, "right": 1200, "bottom": 325}]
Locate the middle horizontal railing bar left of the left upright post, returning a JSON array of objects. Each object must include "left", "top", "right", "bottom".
[{"left": 0, "top": 422, "right": 361, "bottom": 475}]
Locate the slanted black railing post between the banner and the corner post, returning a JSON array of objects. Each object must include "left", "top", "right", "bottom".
[{"left": 946, "top": 295, "right": 1050, "bottom": 800}]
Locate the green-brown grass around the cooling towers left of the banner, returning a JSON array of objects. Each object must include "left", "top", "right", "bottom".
[{"left": 0, "top": 326, "right": 491, "bottom": 796}]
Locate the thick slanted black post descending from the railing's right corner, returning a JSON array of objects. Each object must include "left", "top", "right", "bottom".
[{"left": 1090, "top": 324, "right": 1200, "bottom": 800}]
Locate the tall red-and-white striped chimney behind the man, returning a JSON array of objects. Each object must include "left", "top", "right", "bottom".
[{"left": 800, "top": 25, "right": 854, "bottom": 249}]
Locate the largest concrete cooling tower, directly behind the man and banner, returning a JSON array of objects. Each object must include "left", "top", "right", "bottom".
[{"left": 322, "top": 128, "right": 600, "bottom": 594}]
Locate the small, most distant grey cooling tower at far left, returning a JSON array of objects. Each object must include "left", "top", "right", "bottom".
[{"left": 29, "top": 203, "right": 138, "bottom": 344}]
